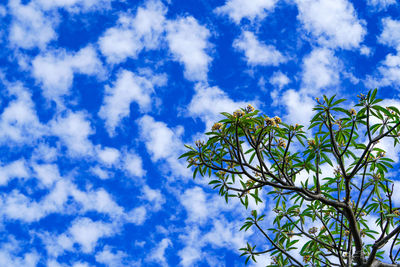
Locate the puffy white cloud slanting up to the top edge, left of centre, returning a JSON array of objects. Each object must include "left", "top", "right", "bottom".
[{"left": 99, "top": 1, "right": 166, "bottom": 64}]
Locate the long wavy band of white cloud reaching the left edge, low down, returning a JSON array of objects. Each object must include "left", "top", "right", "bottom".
[{"left": 0, "top": 175, "right": 153, "bottom": 225}]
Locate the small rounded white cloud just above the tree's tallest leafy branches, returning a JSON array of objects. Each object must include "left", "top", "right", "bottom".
[{"left": 302, "top": 48, "right": 341, "bottom": 96}]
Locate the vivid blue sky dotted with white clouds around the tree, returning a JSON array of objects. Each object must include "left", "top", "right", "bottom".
[{"left": 0, "top": 0, "right": 400, "bottom": 267}]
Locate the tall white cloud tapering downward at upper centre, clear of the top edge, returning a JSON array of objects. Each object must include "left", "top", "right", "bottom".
[{"left": 167, "top": 17, "right": 212, "bottom": 81}]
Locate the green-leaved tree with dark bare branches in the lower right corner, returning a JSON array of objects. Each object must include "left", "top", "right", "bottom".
[{"left": 181, "top": 89, "right": 400, "bottom": 266}]
